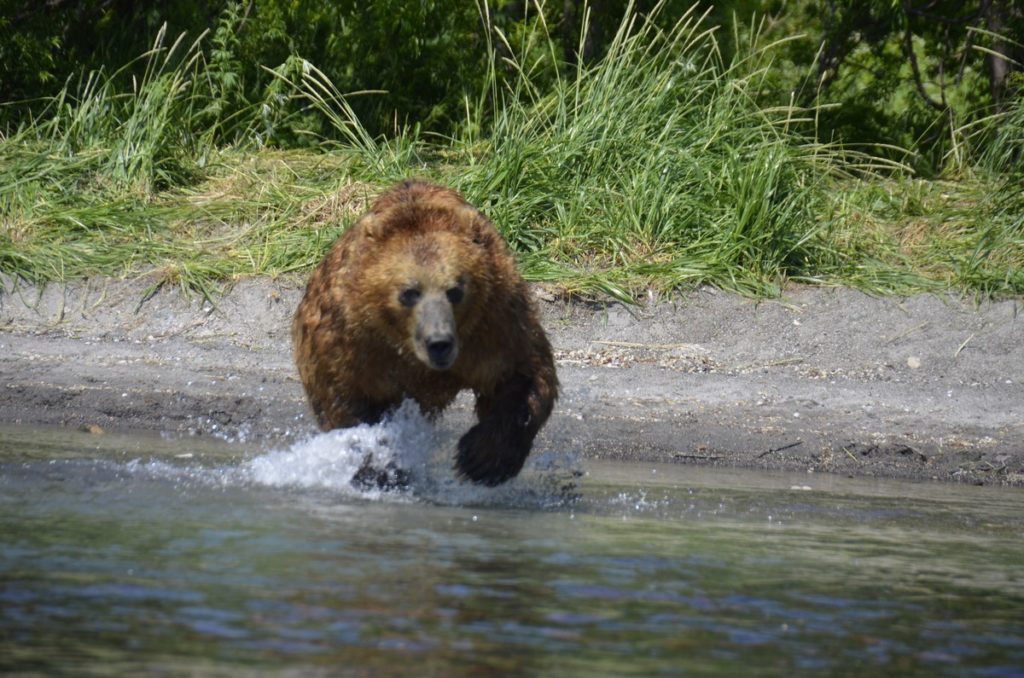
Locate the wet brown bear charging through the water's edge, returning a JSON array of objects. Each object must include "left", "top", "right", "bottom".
[{"left": 292, "top": 180, "right": 558, "bottom": 486}]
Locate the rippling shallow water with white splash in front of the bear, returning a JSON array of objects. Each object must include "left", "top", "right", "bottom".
[{"left": 0, "top": 413, "right": 1024, "bottom": 676}]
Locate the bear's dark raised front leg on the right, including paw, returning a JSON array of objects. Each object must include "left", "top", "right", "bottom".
[{"left": 455, "top": 373, "right": 557, "bottom": 488}]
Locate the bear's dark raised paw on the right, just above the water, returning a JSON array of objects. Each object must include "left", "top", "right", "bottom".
[{"left": 455, "top": 423, "right": 530, "bottom": 488}]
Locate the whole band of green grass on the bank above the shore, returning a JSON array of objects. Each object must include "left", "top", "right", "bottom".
[{"left": 0, "top": 0, "right": 1024, "bottom": 298}]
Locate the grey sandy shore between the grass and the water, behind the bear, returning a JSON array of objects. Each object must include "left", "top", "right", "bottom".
[{"left": 0, "top": 279, "right": 1024, "bottom": 485}]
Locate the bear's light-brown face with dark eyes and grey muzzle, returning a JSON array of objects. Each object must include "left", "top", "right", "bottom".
[{"left": 368, "top": 232, "right": 487, "bottom": 371}]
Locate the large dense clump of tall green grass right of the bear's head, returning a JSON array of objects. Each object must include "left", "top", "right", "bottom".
[{"left": 440, "top": 3, "right": 842, "bottom": 295}]
